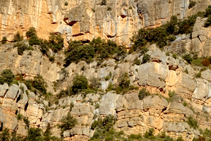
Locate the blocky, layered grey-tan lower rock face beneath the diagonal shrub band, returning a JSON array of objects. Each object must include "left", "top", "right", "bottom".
[{"left": 0, "top": 41, "right": 211, "bottom": 141}]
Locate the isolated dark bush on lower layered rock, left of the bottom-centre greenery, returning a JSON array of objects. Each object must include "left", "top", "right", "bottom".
[{"left": 58, "top": 112, "right": 78, "bottom": 136}]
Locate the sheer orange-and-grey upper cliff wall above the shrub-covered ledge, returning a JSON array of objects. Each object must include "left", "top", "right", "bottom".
[{"left": 0, "top": 0, "right": 211, "bottom": 46}]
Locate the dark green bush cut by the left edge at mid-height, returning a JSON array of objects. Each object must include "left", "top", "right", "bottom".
[{"left": 0, "top": 69, "right": 15, "bottom": 85}]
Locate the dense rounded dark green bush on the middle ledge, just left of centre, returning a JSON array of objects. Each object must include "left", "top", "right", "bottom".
[{"left": 72, "top": 75, "right": 88, "bottom": 93}]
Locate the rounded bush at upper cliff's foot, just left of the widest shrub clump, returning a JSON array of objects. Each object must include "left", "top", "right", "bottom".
[{"left": 49, "top": 33, "right": 64, "bottom": 52}]
